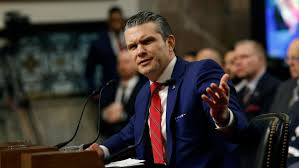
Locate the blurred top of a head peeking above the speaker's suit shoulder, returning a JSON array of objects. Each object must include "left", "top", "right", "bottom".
[{"left": 195, "top": 48, "right": 223, "bottom": 66}]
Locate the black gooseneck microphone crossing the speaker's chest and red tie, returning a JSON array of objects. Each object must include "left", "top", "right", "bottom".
[{"left": 105, "top": 79, "right": 176, "bottom": 164}]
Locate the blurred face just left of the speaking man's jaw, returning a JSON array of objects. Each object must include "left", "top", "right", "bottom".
[{"left": 117, "top": 50, "right": 137, "bottom": 80}]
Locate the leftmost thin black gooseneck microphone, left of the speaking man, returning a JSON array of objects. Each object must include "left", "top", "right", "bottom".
[{"left": 55, "top": 80, "right": 115, "bottom": 149}]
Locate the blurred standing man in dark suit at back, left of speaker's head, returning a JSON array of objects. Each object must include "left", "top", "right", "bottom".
[{"left": 85, "top": 7, "right": 126, "bottom": 92}]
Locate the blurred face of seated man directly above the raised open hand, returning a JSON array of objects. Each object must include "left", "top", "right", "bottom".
[{"left": 235, "top": 43, "right": 263, "bottom": 79}]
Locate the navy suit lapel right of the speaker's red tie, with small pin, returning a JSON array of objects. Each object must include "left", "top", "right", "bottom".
[{"left": 166, "top": 58, "right": 186, "bottom": 163}]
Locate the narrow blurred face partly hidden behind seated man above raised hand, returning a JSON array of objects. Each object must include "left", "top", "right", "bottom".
[{"left": 224, "top": 51, "right": 236, "bottom": 78}]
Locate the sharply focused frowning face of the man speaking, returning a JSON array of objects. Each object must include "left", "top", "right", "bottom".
[{"left": 125, "top": 22, "right": 175, "bottom": 81}]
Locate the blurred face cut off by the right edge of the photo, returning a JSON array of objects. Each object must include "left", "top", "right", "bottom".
[{"left": 286, "top": 39, "right": 299, "bottom": 79}]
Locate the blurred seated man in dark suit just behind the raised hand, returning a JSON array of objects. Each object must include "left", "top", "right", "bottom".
[{"left": 235, "top": 40, "right": 280, "bottom": 120}]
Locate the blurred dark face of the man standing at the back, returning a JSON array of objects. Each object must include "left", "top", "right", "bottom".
[{"left": 109, "top": 12, "right": 124, "bottom": 32}]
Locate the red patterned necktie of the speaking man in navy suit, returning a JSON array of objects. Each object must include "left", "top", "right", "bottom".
[{"left": 150, "top": 82, "right": 165, "bottom": 164}]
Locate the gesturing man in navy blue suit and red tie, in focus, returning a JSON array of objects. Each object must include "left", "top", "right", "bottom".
[{"left": 89, "top": 12, "right": 247, "bottom": 168}]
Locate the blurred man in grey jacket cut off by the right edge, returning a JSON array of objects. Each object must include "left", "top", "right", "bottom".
[{"left": 271, "top": 38, "right": 299, "bottom": 168}]
